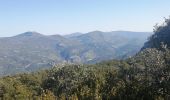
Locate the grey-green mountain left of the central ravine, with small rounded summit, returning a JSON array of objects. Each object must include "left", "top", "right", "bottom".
[{"left": 0, "top": 32, "right": 71, "bottom": 75}]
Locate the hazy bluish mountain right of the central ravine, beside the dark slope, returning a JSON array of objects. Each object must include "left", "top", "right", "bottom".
[{"left": 66, "top": 31, "right": 152, "bottom": 62}]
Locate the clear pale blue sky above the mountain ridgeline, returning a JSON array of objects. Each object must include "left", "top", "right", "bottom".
[{"left": 0, "top": 0, "right": 170, "bottom": 37}]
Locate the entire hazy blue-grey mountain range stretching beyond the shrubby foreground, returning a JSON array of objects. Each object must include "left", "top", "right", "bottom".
[{"left": 0, "top": 31, "right": 152, "bottom": 75}]
